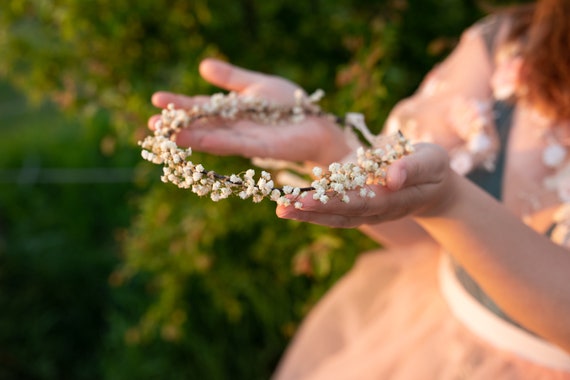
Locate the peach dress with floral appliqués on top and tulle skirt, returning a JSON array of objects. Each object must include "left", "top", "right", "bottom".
[{"left": 274, "top": 14, "right": 570, "bottom": 380}]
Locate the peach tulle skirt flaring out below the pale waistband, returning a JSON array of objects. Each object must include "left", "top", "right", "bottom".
[{"left": 274, "top": 246, "right": 570, "bottom": 380}]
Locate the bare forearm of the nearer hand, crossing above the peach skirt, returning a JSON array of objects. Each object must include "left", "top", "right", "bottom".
[{"left": 415, "top": 171, "right": 570, "bottom": 351}]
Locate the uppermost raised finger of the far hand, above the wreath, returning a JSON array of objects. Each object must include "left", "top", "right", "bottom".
[{"left": 199, "top": 58, "right": 266, "bottom": 91}]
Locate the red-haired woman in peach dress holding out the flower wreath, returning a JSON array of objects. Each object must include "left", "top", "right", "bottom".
[{"left": 149, "top": 0, "right": 570, "bottom": 380}]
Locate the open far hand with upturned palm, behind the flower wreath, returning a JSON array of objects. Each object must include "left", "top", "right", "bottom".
[{"left": 149, "top": 59, "right": 349, "bottom": 165}]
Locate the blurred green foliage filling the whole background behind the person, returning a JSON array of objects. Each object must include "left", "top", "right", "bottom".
[{"left": 0, "top": 0, "right": 512, "bottom": 379}]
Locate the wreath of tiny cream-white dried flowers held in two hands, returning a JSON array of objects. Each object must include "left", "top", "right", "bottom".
[{"left": 139, "top": 91, "right": 413, "bottom": 208}]
